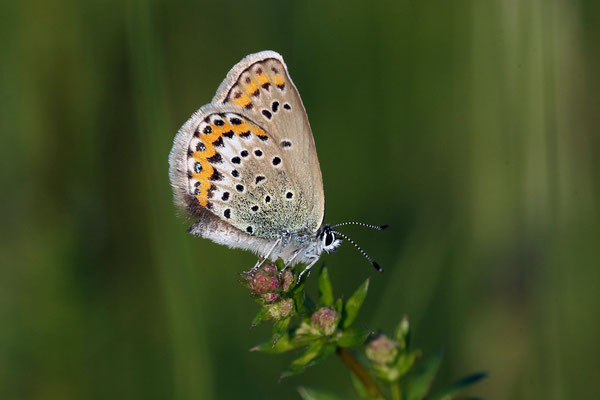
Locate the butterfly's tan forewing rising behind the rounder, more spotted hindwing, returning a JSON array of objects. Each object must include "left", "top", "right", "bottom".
[{"left": 213, "top": 51, "right": 325, "bottom": 231}]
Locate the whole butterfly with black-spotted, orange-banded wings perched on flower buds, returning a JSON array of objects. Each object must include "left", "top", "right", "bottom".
[{"left": 169, "top": 51, "right": 386, "bottom": 273}]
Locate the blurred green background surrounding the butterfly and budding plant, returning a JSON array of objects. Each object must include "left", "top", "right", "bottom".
[{"left": 0, "top": 0, "right": 600, "bottom": 399}]
